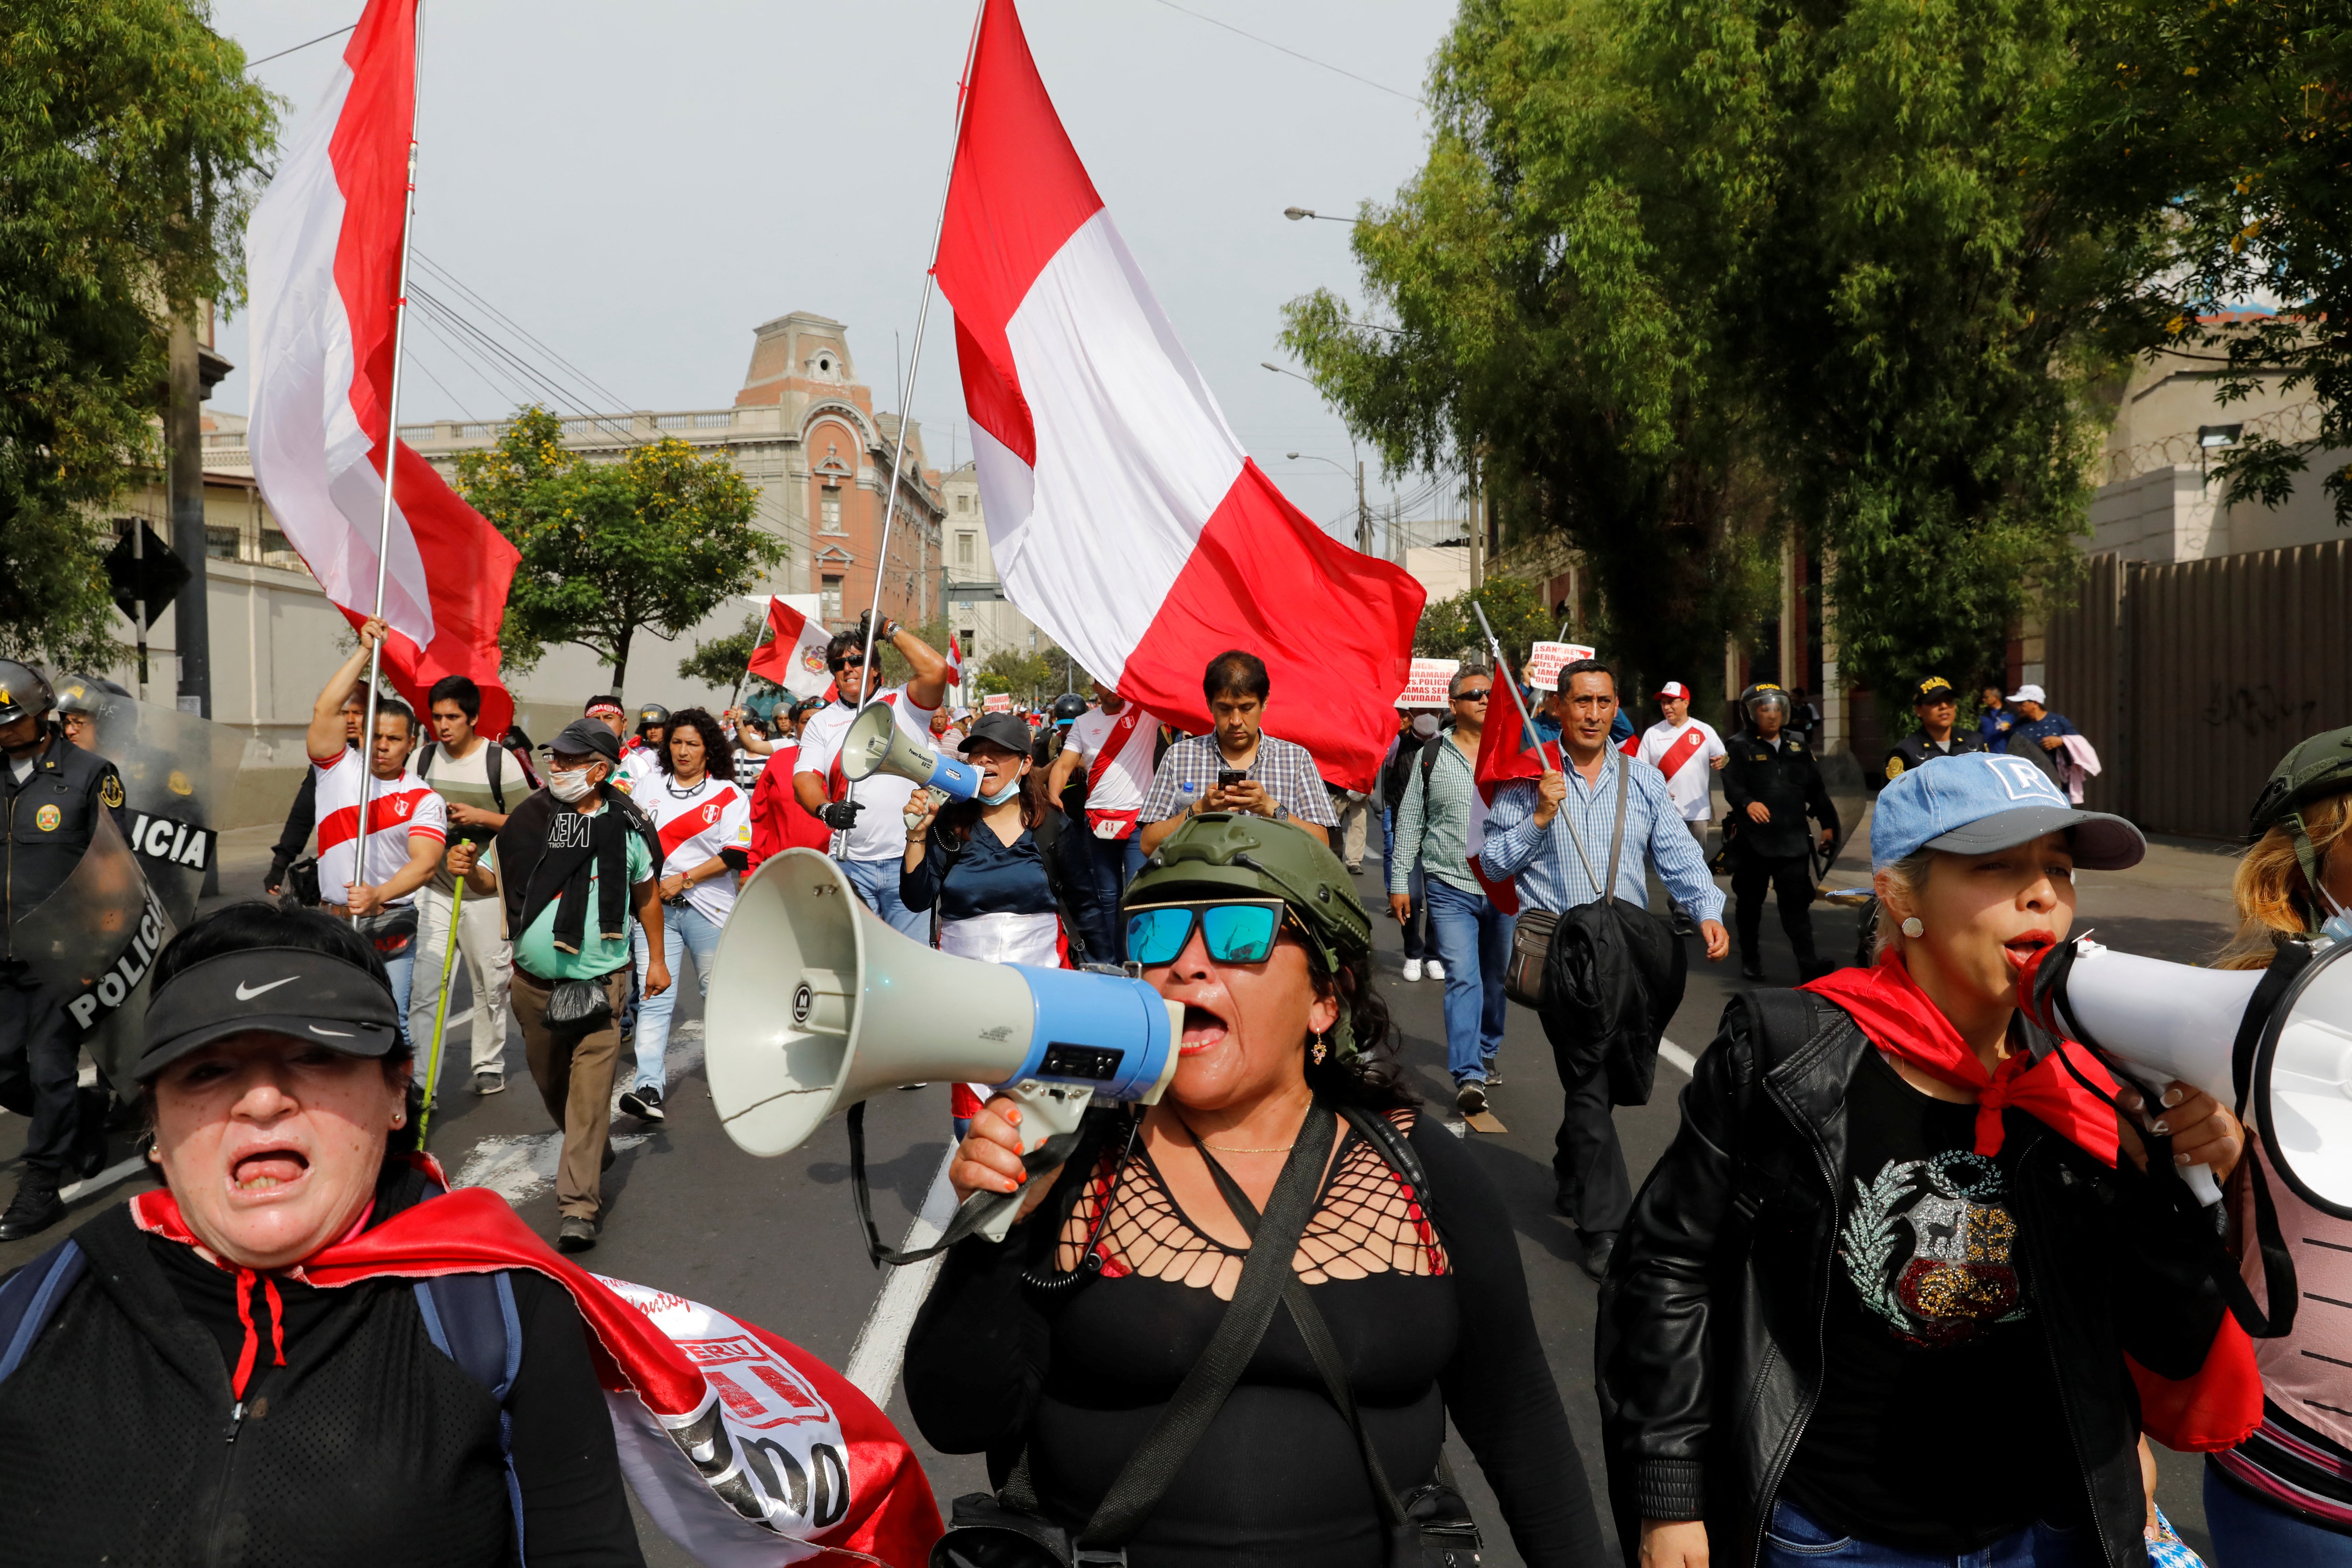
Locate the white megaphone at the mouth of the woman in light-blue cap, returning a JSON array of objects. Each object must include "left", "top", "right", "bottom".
[{"left": 2018, "top": 938, "right": 2352, "bottom": 1220}]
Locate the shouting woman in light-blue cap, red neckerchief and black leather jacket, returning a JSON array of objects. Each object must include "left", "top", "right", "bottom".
[{"left": 1600, "top": 755, "right": 2244, "bottom": 1568}]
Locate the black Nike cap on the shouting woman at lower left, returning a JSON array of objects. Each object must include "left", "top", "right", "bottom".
[{"left": 134, "top": 947, "right": 400, "bottom": 1079}]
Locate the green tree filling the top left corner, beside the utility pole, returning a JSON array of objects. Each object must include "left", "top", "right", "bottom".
[{"left": 0, "top": 0, "right": 278, "bottom": 668}]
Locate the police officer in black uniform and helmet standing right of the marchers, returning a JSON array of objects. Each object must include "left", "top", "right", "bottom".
[{"left": 1724, "top": 684, "right": 1837, "bottom": 980}]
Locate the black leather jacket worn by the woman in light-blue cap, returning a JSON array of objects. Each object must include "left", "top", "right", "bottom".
[{"left": 1597, "top": 992, "right": 2225, "bottom": 1568}]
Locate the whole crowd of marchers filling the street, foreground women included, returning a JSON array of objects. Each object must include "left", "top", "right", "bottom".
[{"left": 0, "top": 618, "right": 2352, "bottom": 1568}]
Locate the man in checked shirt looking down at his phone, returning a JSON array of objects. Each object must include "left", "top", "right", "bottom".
[{"left": 1136, "top": 649, "right": 1338, "bottom": 856}]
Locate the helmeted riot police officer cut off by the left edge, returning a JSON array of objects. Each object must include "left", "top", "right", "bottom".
[{"left": 0, "top": 658, "right": 122, "bottom": 1241}]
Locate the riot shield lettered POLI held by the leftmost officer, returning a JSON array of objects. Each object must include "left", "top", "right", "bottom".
[{"left": 9, "top": 811, "right": 179, "bottom": 1100}]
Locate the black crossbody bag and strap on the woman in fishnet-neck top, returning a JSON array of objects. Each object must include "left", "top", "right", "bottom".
[{"left": 931, "top": 1102, "right": 1338, "bottom": 1568}]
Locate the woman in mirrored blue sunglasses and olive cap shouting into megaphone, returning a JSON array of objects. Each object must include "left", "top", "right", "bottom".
[{"left": 905, "top": 808, "right": 1602, "bottom": 1568}]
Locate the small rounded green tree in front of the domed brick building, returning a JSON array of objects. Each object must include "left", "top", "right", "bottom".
[{"left": 456, "top": 404, "right": 785, "bottom": 691}]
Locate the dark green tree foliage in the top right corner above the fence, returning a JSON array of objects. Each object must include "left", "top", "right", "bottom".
[{"left": 2056, "top": 0, "right": 2352, "bottom": 527}]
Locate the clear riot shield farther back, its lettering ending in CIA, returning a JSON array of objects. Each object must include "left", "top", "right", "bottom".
[{"left": 56, "top": 675, "right": 245, "bottom": 926}]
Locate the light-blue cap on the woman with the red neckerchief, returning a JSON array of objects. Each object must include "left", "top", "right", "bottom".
[{"left": 1870, "top": 752, "right": 2147, "bottom": 872}]
